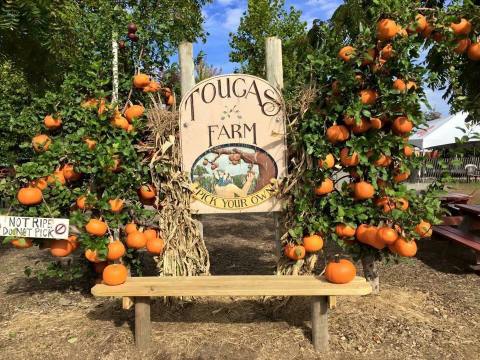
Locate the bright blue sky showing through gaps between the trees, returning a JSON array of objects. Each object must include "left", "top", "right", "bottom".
[{"left": 190, "top": 0, "right": 449, "bottom": 115}]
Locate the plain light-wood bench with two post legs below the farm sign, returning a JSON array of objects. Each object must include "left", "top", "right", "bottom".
[{"left": 92, "top": 275, "right": 372, "bottom": 351}]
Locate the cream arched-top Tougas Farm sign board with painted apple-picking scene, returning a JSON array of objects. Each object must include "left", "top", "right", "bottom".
[{"left": 180, "top": 74, "right": 286, "bottom": 214}]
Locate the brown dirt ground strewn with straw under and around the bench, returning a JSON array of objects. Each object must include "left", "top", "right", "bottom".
[{"left": 0, "top": 215, "right": 480, "bottom": 360}]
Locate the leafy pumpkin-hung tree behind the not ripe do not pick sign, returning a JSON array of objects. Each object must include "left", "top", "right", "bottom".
[{"left": 0, "top": 1, "right": 208, "bottom": 285}]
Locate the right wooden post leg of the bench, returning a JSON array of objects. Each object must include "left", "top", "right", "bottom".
[{"left": 312, "top": 296, "right": 328, "bottom": 353}]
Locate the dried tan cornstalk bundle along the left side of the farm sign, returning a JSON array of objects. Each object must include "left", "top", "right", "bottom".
[{"left": 139, "top": 96, "right": 210, "bottom": 276}]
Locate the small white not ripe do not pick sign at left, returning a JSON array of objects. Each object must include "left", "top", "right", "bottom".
[{"left": 0, "top": 215, "right": 70, "bottom": 239}]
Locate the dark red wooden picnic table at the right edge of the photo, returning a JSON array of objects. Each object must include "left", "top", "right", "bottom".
[{"left": 433, "top": 204, "right": 480, "bottom": 271}]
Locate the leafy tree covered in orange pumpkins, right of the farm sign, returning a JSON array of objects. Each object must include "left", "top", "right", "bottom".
[{"left": 280, "top": 1, "right": 475, "bottom": 292}]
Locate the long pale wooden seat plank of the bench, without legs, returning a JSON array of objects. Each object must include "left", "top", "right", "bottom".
[{"left": 92, "top": 275, "right": 372, "bottom": 297}]
